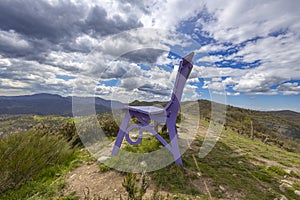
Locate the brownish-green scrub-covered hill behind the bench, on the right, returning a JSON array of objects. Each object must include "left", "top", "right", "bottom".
[{"left": 132, "top": 100, "right": 300, "bottom": 152}]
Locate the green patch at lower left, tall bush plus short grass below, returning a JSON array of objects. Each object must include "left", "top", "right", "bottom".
[{"left": 0, "top": 123, "right": 95, "bottom": 199}]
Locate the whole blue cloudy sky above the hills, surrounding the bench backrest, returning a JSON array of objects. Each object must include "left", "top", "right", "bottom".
[{"left": 0, "top": 0, "right": 300, "bottom": 111}]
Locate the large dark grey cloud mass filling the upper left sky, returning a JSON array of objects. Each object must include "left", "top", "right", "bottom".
[{"left": 0, "top": 0, "right": 142, "bottom": 56}]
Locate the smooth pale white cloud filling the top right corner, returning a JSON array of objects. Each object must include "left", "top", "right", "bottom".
[{"left": 204, "top": 0, "right": 300, "bottom": 44}]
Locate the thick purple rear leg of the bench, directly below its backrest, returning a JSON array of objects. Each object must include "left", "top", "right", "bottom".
[{"left": 168, "top": 125, "right": 183, "bottom": 165}]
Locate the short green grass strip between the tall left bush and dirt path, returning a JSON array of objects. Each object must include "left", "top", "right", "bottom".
[{"left": 0, "top": 149, "right": 94, "bottom": 200}]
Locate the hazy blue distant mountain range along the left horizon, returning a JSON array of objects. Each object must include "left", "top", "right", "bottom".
[{"left": 0, "top": 93, "right": 122, "bottom": 116}]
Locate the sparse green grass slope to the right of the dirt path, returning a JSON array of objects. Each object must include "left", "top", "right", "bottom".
[{"left": 199, "top": 126, "right": 300, "bottom": 199}]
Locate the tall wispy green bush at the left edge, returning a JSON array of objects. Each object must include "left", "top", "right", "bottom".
[{"left": 0, "top": 131, "right": 73, "bottom": 194}]
